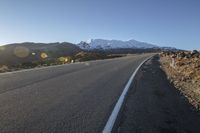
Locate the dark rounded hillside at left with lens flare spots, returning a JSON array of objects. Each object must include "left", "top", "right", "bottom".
[{"left": 0, "top": 42, "right": 81, "bottom": 66}]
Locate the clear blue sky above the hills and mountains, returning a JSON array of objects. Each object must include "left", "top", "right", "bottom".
[{"left": 0, "top": 0, "right": 200, "bottom": 49}]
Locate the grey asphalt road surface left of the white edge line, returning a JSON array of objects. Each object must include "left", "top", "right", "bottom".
[{"left": 0, "top": 55, "right": 150, "bottom": 133}]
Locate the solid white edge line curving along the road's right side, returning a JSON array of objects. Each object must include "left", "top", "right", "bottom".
[{"left": 102, "top": 55, "right": 154, "bottom": 133}]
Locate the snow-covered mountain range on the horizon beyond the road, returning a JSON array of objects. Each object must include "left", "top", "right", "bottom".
[{"left": 78, "top": 39, "right": 159, "bottom": 50}]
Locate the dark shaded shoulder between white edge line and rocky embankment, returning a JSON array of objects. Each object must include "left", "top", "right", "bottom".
[{"left": 113, "top": 57, "right": 200, "bottom": 133}]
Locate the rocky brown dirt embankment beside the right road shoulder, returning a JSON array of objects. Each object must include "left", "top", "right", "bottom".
[{"left": 160, "top": 50, "right": 200, "bottom": 110}]
